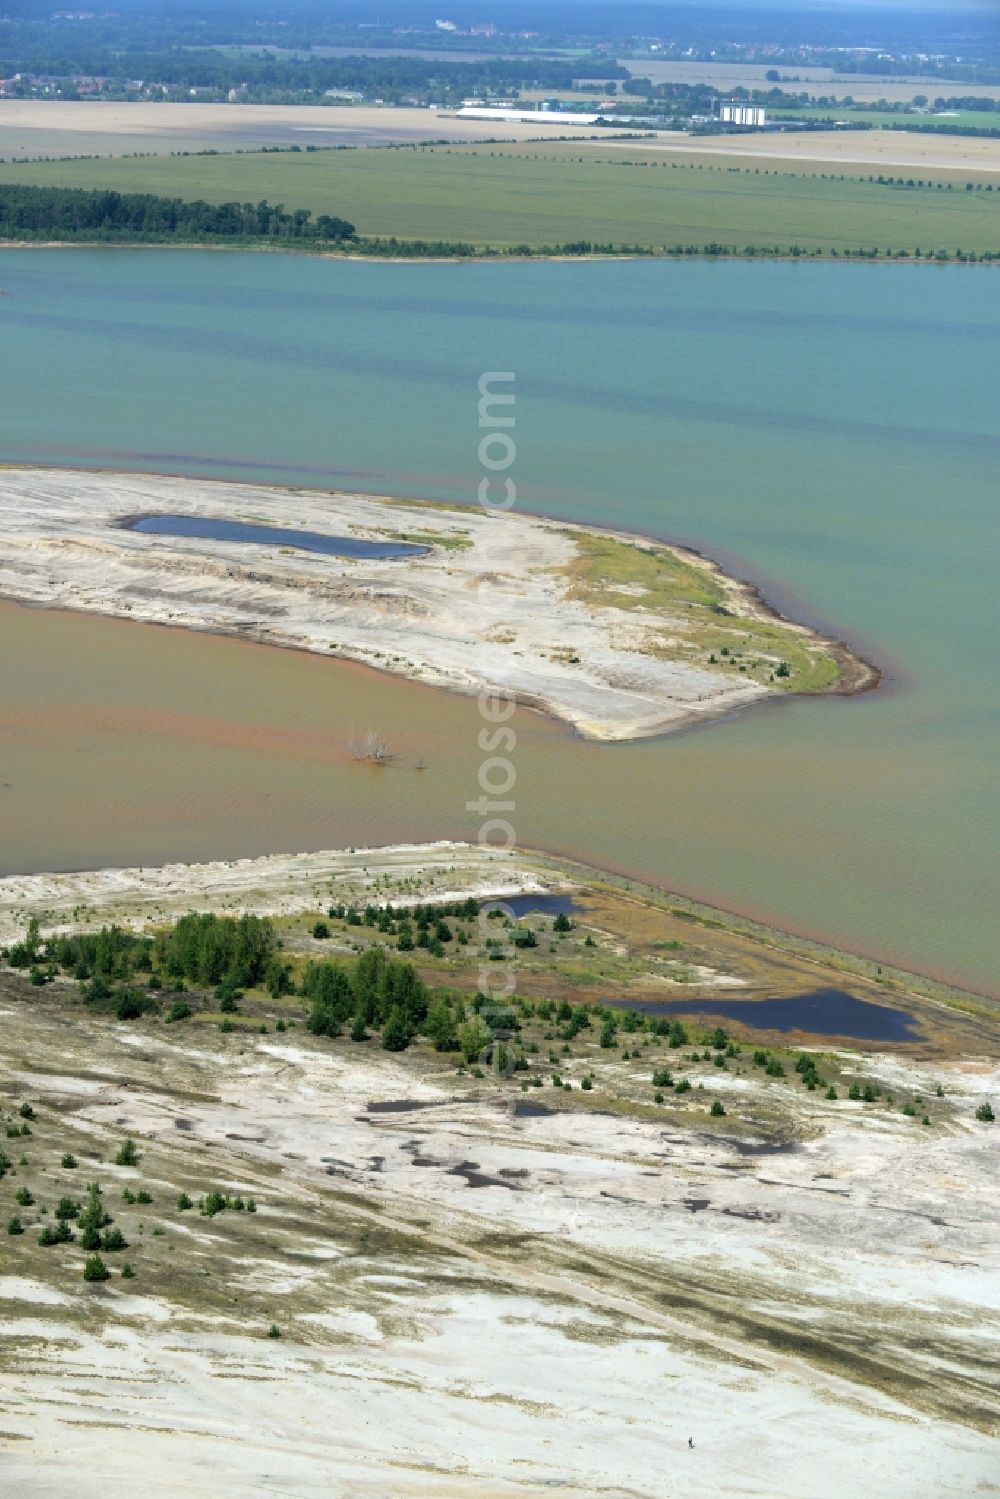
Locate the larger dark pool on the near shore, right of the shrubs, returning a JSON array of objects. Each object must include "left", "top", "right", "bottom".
[{"left": 607, "top": 989, "right": 921, "bottom": 1040}]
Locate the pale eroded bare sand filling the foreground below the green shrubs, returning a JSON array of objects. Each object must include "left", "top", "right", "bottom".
[{"left": 0, "top": 991, "right": 1000, "bottom": 1499}]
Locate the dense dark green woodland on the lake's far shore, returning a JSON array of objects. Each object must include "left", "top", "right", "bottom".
[{"left": 0, "top": 183, "right": 355, "bottom": 241}]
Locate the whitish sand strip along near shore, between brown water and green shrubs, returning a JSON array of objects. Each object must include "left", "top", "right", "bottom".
[{"left": 0, "top": 839, "right": 554, "bottom": 944}]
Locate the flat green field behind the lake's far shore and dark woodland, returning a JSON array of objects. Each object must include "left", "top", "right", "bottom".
[{"left": 0, "top": 142, "right": 1000, "bottom": 255}]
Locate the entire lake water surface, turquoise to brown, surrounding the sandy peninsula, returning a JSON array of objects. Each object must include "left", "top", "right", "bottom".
[{"left": 0, "top": 250, "right": 1000, "bottom": 989}]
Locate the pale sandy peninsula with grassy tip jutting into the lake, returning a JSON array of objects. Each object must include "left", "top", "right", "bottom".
[{"left": 0, "top": 468, "right": 877, "bottom": 741}]
